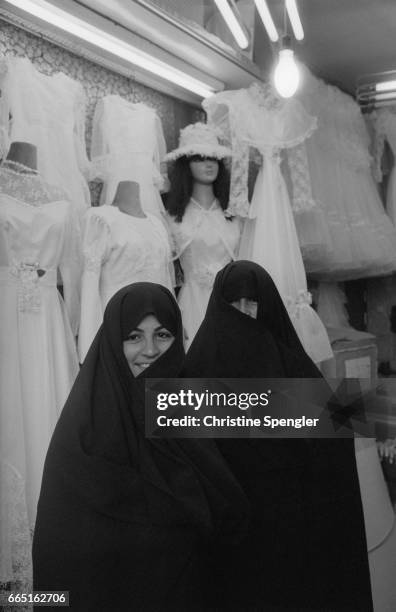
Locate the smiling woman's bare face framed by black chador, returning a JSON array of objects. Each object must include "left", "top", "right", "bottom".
[{"left": 123, "top": 315, "right": 175, "bottom": 377}]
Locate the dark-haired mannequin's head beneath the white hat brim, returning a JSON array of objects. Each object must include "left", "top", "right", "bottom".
[{"left": 166, "top": 155, "right": 230, "bottom": 222}]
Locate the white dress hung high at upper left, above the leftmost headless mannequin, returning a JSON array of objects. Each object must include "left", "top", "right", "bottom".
[{"left": 0, "top": 56, "right": 91, "bottom": 215}]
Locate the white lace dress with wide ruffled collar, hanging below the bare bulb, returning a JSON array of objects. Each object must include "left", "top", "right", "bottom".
[{"left": 203, "top": 83, "right": 333, "bottom": 363}]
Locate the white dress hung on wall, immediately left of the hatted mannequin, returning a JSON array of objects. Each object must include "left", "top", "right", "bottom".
[{"left": 91, "top": 95, "right": 166, "bottom": 216}]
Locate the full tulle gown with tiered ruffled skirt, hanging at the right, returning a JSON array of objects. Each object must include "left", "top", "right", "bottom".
[{"left": 297, "top": 67, "right": 396, "bottom": 281}]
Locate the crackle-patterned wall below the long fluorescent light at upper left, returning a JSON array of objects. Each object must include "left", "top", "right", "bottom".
[{"left": 0, "top": 20, "right": 200, "bottom": 205}]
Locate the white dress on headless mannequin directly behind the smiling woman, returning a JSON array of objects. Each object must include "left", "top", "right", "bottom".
[{"left": 78, "top": 206, "right": 173, "bottom": 362}]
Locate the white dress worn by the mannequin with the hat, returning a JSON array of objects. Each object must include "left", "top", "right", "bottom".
[{"left": 167, "top": 198, "right": 240, "bottom": 349}]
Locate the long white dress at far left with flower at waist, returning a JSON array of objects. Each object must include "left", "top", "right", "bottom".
[{"left": 0, "top": 167, "right": 79, "bottom": 590}]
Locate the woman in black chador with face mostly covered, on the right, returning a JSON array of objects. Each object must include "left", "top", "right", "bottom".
[{"left": 183, "top": 261, "right": 373, "bottom": 612}]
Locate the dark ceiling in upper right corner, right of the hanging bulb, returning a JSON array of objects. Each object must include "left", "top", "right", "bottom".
[{"left": 267, "top": 0, "right": 396, "bottom": 94}]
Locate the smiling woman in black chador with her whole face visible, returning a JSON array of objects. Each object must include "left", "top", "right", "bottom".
[{"left": 33, "top": 283, "right": 246, "bottom": 612}]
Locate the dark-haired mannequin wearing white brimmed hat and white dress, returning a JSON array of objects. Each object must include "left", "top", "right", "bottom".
[{"left": 165, "top": 123, "right": 240, "bottom": 347}]
